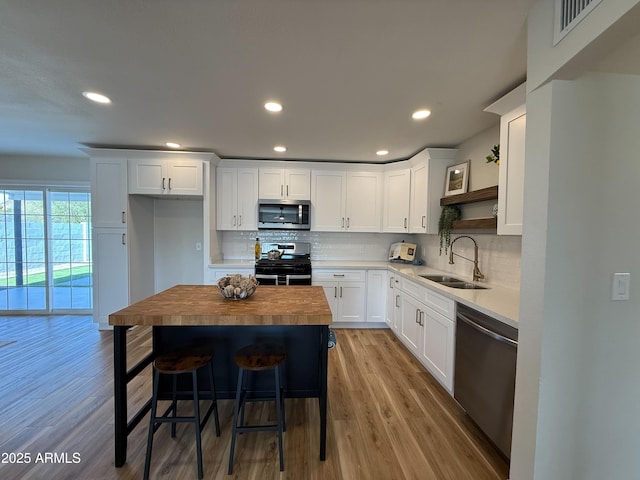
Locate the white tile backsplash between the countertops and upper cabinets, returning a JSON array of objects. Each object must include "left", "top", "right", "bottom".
[{"left": 218, "top": 230, "right": 522, "bottom": 289}]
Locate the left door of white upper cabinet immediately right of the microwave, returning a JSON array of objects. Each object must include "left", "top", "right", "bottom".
[{"left": 311, "top": 170, "right": 347, "bottom": 232}]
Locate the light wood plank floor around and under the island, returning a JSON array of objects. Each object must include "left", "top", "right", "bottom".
[{"left": 0, "top": 316, "right": 508, "bottom": 480}]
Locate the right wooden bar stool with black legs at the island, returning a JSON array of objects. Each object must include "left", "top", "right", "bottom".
[{"left": 228, "top": 344, "right": 287, "bottom": 475}]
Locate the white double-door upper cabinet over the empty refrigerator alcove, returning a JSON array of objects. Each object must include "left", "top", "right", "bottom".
[{"left": 129, "top": 159, "right": 203, "bottom": 196}]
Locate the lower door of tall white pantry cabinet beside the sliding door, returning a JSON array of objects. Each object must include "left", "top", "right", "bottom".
[{"left": 92, "top": 228, "right": 129, "bottom": 324}]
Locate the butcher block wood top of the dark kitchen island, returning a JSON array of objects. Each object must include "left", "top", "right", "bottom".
[{"left": 109, "top": 285, "right": 332, "bottom": 326}]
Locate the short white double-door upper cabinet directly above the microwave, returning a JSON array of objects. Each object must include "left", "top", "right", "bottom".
[{"left": 258, "top": 168, "right": 311, "bottom": 200}]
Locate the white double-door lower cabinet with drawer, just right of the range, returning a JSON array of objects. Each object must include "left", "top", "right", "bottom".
[{"left": 312, "top": 270, "right": 366, "bottom": 323}]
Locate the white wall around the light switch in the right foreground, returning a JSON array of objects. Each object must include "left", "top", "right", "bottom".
[{"left": 510, "top": 74, "right": 640, "bottom": 480}]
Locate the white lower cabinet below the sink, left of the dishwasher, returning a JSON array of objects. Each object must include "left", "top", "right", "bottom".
[{"left": 387, "top": 276, "right": 455, "bottom": 393}]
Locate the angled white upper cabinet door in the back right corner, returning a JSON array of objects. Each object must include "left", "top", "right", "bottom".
[{"left": 382, "top": 169, "right": 411, "bottom": 233}]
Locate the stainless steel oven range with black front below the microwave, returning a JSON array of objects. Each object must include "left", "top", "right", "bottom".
[{"left": 255, "top": 242, "right": 311, "bottom": 285}]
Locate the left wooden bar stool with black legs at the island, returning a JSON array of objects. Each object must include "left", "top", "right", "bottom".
[{"left": 144, "top": 350, "right": 220, "bottom": 480}]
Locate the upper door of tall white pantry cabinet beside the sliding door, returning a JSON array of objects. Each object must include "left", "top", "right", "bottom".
[{"left": 91, "top": 158, "right": 128, "bottom": 228}]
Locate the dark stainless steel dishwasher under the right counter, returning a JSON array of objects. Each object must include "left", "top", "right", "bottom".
[{"left": 454, "top": 304, "right": 518, "bottom": 458}]
